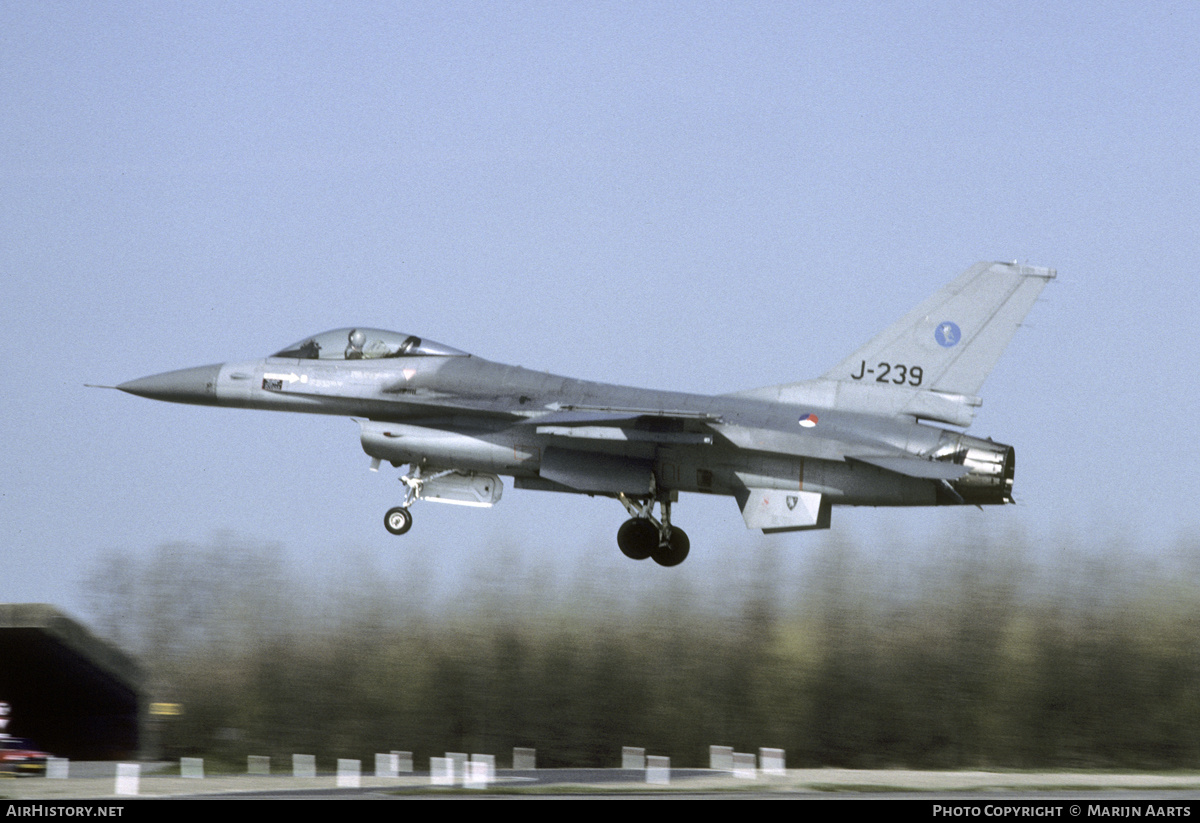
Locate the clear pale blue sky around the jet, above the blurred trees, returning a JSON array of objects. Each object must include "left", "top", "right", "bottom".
[{"left": 0, "top": 1, "right": 1200, "bottom": 609}]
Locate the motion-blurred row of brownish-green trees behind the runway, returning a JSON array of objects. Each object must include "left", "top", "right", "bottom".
[{"left": 85, "top": 534, "right": 1200, "bottom": 769}]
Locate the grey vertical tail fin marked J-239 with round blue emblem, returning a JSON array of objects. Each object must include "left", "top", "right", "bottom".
[{"left": 823, "top": 263, "right": 1056, "bottom": 397}]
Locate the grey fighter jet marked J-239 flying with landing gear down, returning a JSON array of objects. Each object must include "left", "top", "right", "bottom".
[{"left": 116, "top": 263, "right": 1056, "bottom": 566}]
